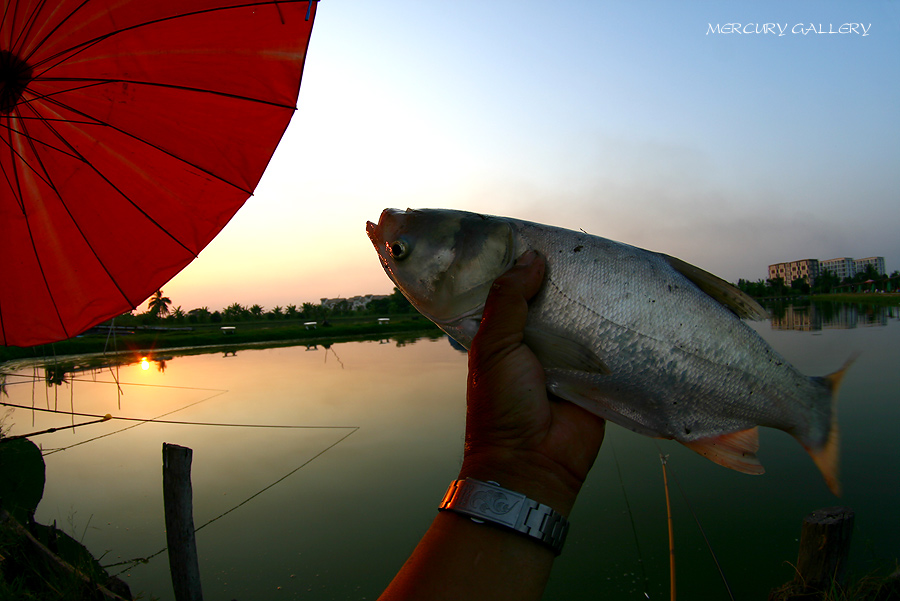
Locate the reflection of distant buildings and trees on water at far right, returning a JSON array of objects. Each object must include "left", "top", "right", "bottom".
[{"left": 772, "top": 303, "right": 900, "bottom": 332}]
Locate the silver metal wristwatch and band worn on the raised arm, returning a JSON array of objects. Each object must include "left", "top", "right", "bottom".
[{"left": 438, "top": 478, "right": 569, "bottom": 555}]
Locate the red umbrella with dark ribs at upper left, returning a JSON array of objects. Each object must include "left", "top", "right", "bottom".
[{"left": 0, "top": 0, "right": 316, "bottom": 346}]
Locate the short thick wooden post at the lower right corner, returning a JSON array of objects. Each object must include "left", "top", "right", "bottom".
[{"left": 794, "top": 507, "right": 853, "bottom": 591}]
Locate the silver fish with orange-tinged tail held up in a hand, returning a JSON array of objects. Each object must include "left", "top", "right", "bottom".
[{"left": 366, "top": 209, "right": 847, "bottom": 494}]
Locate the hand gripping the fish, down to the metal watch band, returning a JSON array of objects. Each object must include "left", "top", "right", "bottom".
[{"left": 460, "top": 251, "right": 605, "bottom": 516}]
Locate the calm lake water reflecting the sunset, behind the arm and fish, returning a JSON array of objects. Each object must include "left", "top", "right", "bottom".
[{"left": 2, "top": 307, "right": 900, "bottom": 601}]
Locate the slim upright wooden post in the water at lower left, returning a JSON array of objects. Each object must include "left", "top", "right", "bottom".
[{"left": 163, "top": 442, "right": 203, "bottom": 601}]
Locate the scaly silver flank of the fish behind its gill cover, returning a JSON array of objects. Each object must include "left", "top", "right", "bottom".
[{"left": 517, "top": 224, "right": 813, "bottom": 441}]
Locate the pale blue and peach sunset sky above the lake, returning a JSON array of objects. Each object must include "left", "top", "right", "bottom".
[{"left": 156, "top": 0, "right": 900, "bottom": 311}]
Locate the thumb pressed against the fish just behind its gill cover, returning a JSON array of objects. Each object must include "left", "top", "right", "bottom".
[{"left": 476, "top": 251, "right": 545, "bottom": 351}]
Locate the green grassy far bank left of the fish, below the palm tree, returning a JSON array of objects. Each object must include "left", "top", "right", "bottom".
[{"left": 0, "top": 315, "right": 439, "bottom": 362}]
